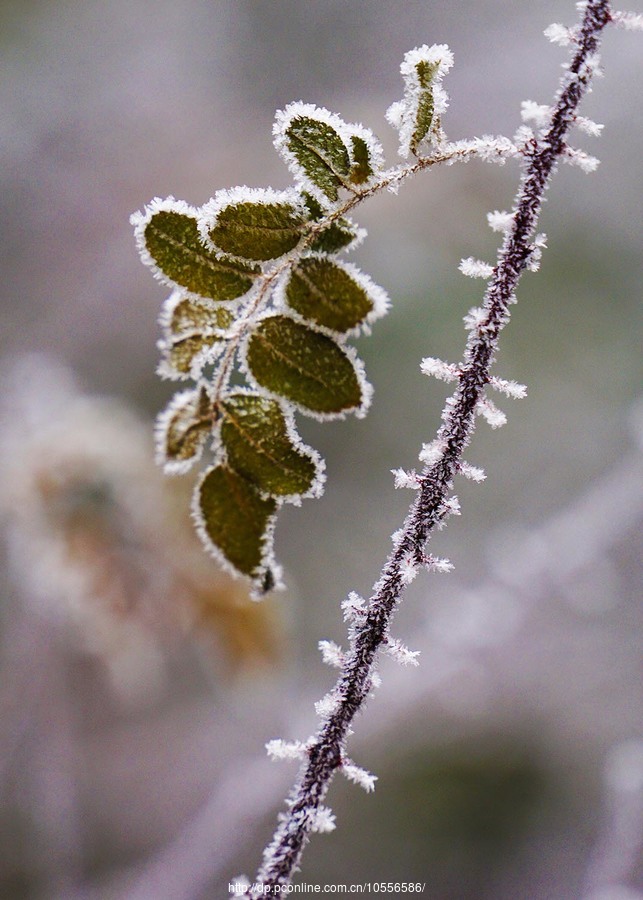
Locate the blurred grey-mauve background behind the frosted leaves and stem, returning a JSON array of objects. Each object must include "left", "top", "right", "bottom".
[{"left": 0, "top": 0, "right": 643, "bottom": 900}]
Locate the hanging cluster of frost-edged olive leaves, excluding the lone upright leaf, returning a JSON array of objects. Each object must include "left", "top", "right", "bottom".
[{"left": 132, "top": 104, "right": 388, "bottom": 594}]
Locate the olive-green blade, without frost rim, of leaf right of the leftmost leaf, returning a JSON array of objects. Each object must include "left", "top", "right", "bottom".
[{"left": 208, "top": 202, "right": 304, "bottom": 260}]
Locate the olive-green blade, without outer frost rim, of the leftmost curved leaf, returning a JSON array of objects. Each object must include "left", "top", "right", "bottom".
[{"left": 144, "top": 209, "right": 259, "bottom": 300}]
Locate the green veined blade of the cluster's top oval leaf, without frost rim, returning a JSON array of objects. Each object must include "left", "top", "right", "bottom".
[{"left": 285, "top": 115, "right": 351, "bottom": 200}]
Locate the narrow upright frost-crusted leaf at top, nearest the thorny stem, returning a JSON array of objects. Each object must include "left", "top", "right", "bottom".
[{"left": 386, "top": 44, "right": 453, "bottom": 159}]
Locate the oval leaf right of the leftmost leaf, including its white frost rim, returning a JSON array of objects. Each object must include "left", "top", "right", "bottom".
[{"left": 199, "top": 187, "right": 305, "bottom": 261}]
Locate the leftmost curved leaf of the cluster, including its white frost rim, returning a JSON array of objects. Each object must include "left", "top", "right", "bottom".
[{"left": 130, "top": 197, "right": 259, "bottom": 300}]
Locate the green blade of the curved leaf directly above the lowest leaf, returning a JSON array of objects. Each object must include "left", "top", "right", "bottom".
[{"left": 221, "top": 393, "right": 318, "bottom": 497}]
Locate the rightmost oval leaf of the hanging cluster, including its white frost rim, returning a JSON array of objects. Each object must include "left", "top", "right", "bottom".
[{"left": 279, "top": 256, "right": 388, "bottom": 334}]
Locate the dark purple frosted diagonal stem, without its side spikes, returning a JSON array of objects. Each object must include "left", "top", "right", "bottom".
[{"left": 248, "top": 0, "right": 611, "bottom": 896}]
